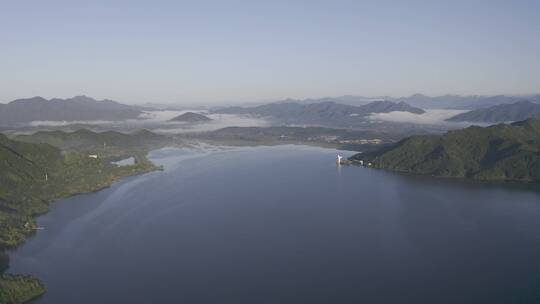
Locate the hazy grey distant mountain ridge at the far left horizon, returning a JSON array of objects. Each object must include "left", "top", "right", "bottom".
[{"left": 0, "top": 96, "right": 142, "bottom": 126}]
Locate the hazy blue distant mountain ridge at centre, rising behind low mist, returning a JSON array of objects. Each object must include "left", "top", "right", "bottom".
[{"left": 215, "top": 100, "right": 424, "bottom": 127}]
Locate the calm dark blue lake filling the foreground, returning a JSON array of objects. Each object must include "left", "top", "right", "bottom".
[{"left": 9, "top": 146, "right": 540, "bottom": 304}]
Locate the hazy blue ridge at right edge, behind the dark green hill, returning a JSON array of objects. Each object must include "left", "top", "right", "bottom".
[{"left": 447, "top": 100, "right": 540, "bottom": 122}]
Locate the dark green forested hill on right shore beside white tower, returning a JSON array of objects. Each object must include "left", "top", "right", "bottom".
[{"left": 350, "top": 118, "right": 540, "bottom": 181}]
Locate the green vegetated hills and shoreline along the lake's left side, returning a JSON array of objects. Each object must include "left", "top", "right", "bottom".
[{"left": 0, "top": 130, "right": 172, "bottom": 303}]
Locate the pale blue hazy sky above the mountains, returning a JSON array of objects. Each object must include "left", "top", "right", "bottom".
[{"left": 0, "top": 0, "right": 540, "bottom": 103}]
